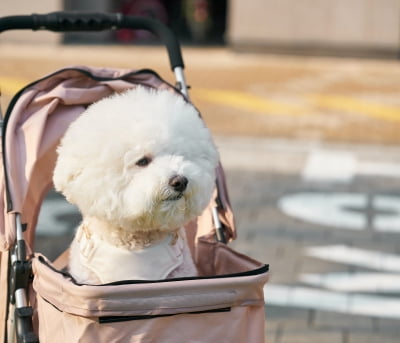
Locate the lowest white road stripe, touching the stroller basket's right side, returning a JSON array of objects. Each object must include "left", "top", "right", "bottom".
[{"left": 264, "top": 284, "right": 400, "bottom": 319}]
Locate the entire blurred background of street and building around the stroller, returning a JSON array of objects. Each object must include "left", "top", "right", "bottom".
[{"left": 0, "top": 0, "right": 400, "bottom": 343}]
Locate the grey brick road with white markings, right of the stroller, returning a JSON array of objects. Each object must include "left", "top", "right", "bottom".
[{"left": 219, "top": 139, "right": 400, "bottom": 343}]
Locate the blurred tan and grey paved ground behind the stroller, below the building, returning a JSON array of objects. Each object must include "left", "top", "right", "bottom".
[{"left": 0, "top": 45, "right": 400, "bottom": 343}]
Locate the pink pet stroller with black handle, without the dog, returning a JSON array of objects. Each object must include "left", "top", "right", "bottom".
[{"left": 0, "top": 12, "right": 268, "bottom": 343}]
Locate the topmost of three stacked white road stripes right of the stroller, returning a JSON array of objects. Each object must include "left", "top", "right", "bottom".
[{"left": 305, "top": 245, "right": 400, "bottom": 273}]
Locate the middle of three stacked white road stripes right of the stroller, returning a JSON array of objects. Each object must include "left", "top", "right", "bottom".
[{"left": 299, "top": 273, "right": 400, "bottom": 293}]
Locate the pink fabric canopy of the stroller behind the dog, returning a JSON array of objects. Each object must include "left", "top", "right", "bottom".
[{"left": 0, "top": 67, "right": 234, "bottom": 251}]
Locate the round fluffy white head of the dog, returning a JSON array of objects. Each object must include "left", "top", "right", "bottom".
[{"left": 53, "top": 87, "right": 219, "bottom": 234}]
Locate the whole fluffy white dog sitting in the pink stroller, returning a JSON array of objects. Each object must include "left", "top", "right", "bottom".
[{"left": 53, "top": 86, "right": 219, "bottom": 284}]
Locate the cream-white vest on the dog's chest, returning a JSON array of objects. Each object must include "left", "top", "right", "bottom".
[{"left": 78, "top": 227, "right": 184, "bottom": 283}]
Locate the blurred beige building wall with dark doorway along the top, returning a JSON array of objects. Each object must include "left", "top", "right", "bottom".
[{"left": 0, "top": 0, "right": 400, "bottom": 57}]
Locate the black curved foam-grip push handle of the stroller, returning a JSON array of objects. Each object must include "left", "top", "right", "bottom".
[{"left": 0, "top": 12, "right": 184, "bottom": 70}]
